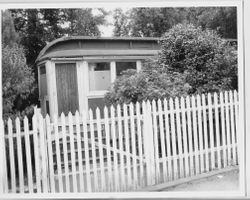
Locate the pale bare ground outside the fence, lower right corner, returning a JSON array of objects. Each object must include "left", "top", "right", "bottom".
[{"left": 161, "top": 169, "right": 239, "bottom": 192}]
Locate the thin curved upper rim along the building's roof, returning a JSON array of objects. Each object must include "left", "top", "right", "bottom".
[{"left": 36, "top": 36, "right": 160, "bottom": 63}]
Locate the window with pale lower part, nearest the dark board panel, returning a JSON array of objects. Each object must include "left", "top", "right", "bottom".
[{"left": 89, "top": 62, "right": 111, "bottom": 91}]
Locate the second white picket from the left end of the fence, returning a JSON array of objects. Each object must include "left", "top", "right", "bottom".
[{"left": 16, "top": 118, "right": 24, "bottom": 193}]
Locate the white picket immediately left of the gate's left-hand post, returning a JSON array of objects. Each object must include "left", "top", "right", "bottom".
[{"left": 32, "top": 115, "right": 41, "bottom": 193}]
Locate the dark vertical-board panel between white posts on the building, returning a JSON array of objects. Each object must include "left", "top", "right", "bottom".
[{"left": 55, "top": 63, "right": 79, "bottom": 115}]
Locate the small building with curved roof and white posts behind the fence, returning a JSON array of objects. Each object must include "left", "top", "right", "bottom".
[{"left": 36, "top": 36, "right": 159, "bottom": 115}]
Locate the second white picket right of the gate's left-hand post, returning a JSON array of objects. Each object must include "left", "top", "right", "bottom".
[{"left": 53, "top": 114, "right": 64, "bottom": 192}]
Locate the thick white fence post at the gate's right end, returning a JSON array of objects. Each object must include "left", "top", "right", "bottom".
[{"left": 143, "top": 101, "right": 155, "bottom": 185}]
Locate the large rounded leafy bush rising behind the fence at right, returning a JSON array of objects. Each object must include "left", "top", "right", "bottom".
[{"left": 158, "top": 24, "right": 237, "bottom": 94}]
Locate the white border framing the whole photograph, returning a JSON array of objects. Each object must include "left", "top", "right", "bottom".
[{"left": 0, "top": 0, "right": 246, "bottom": 199}]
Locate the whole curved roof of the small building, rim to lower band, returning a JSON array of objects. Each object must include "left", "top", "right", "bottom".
[{"left": 36, "top": 36, "right": 159, "bottom": 63}]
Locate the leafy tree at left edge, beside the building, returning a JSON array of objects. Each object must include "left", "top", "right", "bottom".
[{"left": 2, "top": 11, "right": 34, "bottom": 119}]
